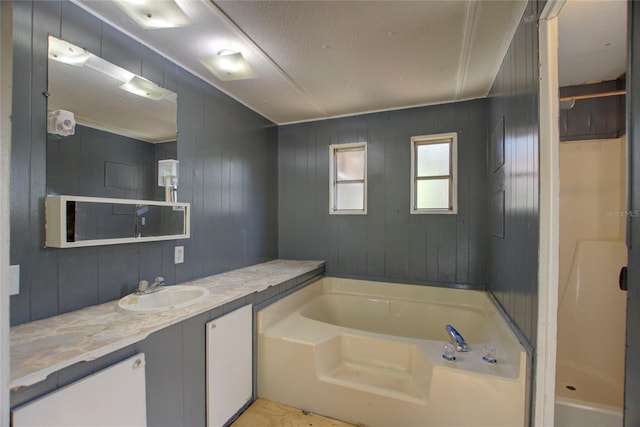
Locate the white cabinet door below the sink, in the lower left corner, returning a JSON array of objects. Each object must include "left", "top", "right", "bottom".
[{"left": 12, "top": 353, "right": 147, "bottom": 427}]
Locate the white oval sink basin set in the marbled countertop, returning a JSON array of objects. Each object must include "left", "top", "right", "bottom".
[{"left": 116, "top": 285, "right": 209, "bottom": 314}]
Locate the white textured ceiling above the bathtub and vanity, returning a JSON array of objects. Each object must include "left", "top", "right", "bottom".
[{"left": 75, "top": 0, "right": 526, "bottom": 124}]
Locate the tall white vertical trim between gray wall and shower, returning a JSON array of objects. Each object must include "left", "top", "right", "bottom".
[{"left": 532, "top": 0, "right": 565, "bottom": 427}]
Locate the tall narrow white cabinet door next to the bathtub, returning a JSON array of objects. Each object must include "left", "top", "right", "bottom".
[{"left": 206, "top": 305, "right": 253, "bottom": 427}]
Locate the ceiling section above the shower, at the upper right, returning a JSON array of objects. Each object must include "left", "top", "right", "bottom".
[{"left": 558, "top": 0, "right": 627, "bottom": 86}]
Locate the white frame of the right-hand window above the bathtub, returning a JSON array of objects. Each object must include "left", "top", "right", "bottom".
[{"left": 410, "top": 132, "right": 458, "bottom": 214}]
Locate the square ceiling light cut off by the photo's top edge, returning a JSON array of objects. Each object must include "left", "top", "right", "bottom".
[{"left": 114, "top": 0, "right": 191, "bottom": 30}]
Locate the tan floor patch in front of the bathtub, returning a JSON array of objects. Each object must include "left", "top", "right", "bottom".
[{"left": 230, "top": 399, "right": 355, "bottom": 427}]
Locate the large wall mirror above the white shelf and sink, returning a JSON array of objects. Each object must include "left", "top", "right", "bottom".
[{"left": 47, "top": 37, "right": 177, "bottom": 200}]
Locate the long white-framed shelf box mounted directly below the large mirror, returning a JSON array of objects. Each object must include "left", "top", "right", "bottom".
[{"left": 45, "top": 195, "right": 191, "bottom": 248}]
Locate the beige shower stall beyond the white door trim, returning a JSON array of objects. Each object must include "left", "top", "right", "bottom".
[{"left": 555, "top": 137, "right": 637, "bottom": 427}]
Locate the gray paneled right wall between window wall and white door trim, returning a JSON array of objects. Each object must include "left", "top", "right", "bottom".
[{"left": 487, "top": 1, "right": 542, "bottom": 345}]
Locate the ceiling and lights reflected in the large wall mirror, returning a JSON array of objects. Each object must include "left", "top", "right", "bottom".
[{"left": 47, "top": 36, "right": 177, "bottom": 143}]
